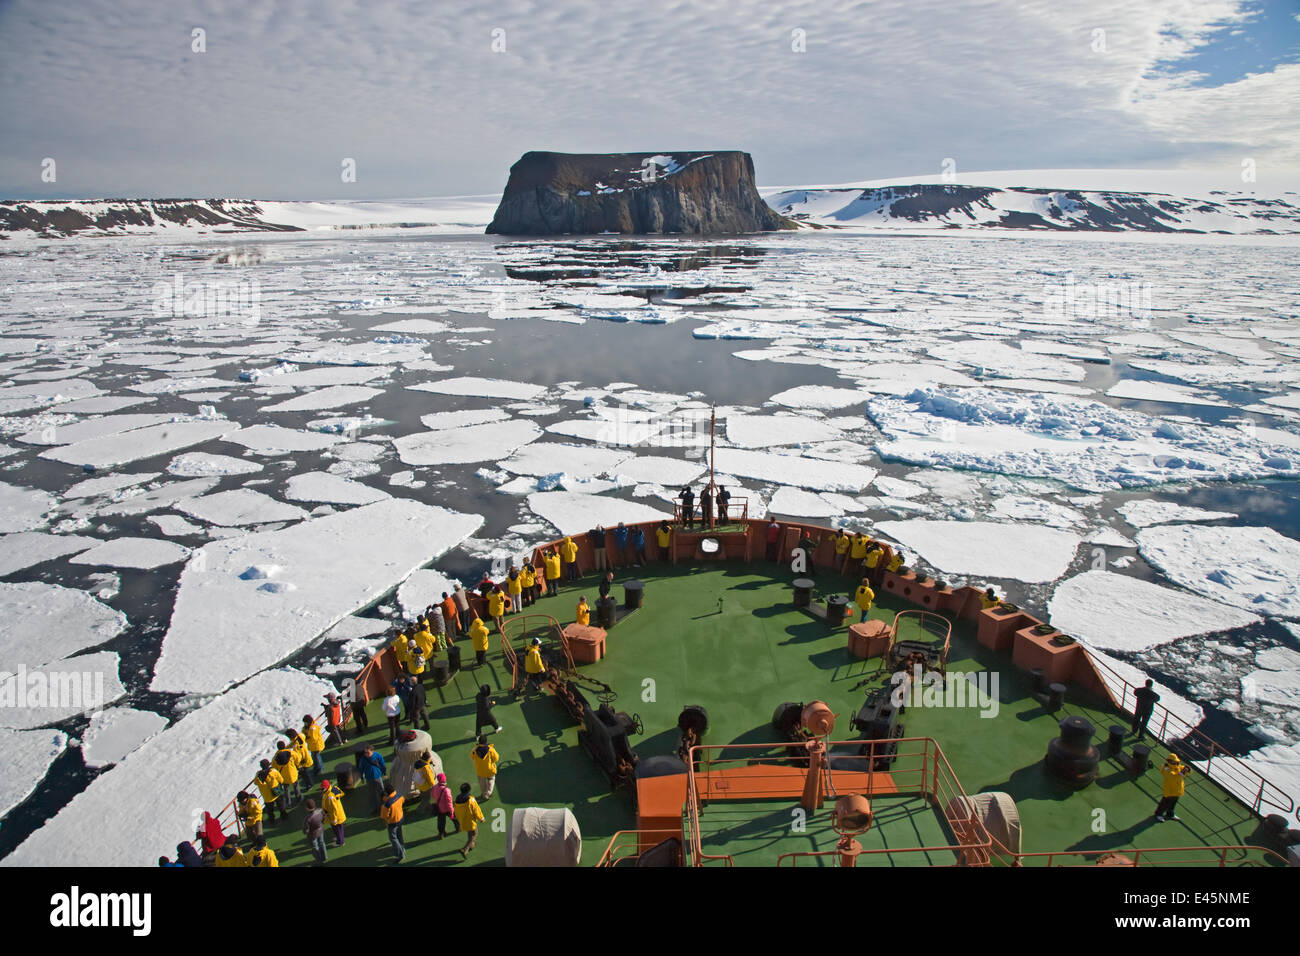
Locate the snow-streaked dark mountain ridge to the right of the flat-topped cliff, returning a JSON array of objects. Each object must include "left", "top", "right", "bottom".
[{"left": 766, "top": 183, "right": 1300, "bottom": 235}]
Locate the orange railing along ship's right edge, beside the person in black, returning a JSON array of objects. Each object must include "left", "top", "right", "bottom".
[{"left": 1088, "top": 654, "right": 1296, "bottom": 814}]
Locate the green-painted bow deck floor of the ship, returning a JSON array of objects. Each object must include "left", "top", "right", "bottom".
[{"left": 256, "top": 564, "right": 1279, "bottom": 866}]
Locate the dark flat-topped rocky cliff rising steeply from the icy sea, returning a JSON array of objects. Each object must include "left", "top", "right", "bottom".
[{"left": 488, "top": 151, "right": 794, "bottom": 235}]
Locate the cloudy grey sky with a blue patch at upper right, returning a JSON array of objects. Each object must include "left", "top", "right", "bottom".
[{"left": 0, "top": 0, "right": 1300, "bottom": 199}]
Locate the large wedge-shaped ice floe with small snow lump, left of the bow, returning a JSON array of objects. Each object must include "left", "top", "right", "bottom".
[{"left": 152, "top": 498, "right": 482, "bottom": 692}]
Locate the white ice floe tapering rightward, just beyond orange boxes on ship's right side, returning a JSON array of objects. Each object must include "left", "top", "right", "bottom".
[{"left": 1048, "top": 571, "right": 1258, "bottom": 652}]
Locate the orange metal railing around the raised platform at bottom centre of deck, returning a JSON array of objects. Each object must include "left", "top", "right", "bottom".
[{"left": 684, "top": 737, "right": 992, "bottom": 866}]
